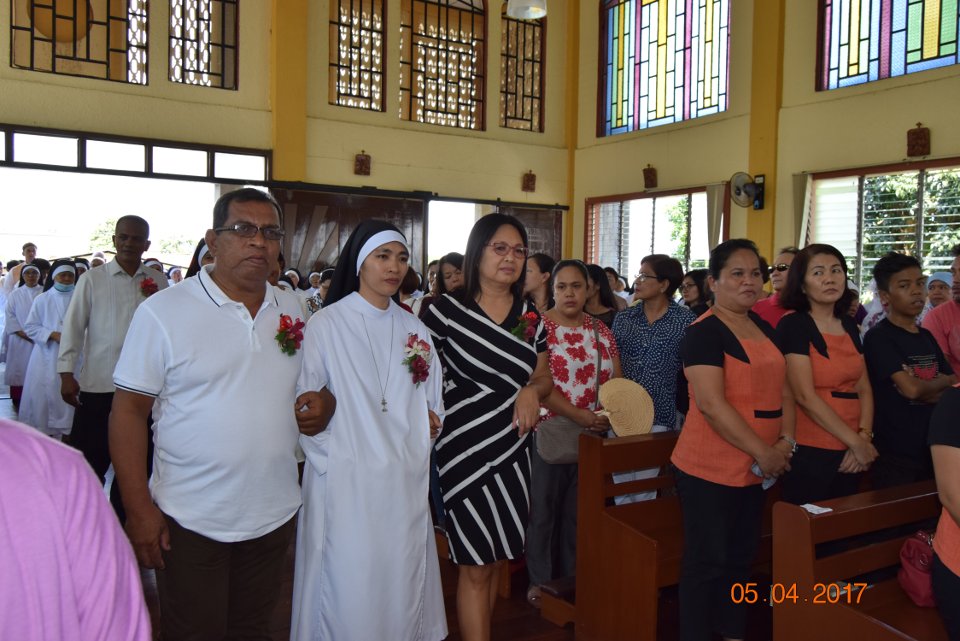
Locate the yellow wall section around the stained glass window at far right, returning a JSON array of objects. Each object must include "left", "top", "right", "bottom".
[{"left": 775, "top": 0, "right": 960, "bottom": 251}]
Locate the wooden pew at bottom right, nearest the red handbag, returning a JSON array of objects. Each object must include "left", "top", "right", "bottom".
[{"left": 772, "top": 481, "right": 947, "bottom": 641}]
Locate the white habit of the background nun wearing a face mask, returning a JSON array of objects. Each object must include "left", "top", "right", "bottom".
[{"left": 18, "top": 288, "right": 80, "bottom": 436}]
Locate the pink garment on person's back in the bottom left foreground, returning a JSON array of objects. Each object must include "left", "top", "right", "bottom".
[{"left": 0, "top": 419, "right": 151, "bottom": 641}]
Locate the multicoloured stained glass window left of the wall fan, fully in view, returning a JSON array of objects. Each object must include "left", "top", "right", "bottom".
[{"left": 597, "top": 0, "right": 730, "bottom": 136}]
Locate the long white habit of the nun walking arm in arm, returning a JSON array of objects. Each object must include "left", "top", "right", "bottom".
[{"left": 290, "top": 293, "right": 447, "bottom": 641}]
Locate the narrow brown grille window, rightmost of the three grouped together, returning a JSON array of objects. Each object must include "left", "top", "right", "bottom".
[{"left": 500, "top": 8, "right": 545, "bottom": 131}]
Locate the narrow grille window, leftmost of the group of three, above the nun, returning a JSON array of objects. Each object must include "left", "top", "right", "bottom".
[{"left": 328, "top": 0, "right": 384, "bottom": 111}]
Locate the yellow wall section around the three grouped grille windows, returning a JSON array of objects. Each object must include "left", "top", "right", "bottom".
[{"left": 306, "top": 0, "right": 567, "bottom": 204}]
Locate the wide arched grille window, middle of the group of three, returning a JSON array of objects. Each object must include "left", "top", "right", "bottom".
[{"left": 400, "top": 0, "right": 486, "bottom": 129}]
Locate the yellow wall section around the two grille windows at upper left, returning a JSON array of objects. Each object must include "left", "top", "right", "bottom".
[{"left": 0, "top": 1, "right": 271, "bottom": 149}]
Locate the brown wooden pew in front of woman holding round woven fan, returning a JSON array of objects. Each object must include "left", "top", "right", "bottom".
[{"left": 541, "top": 432, "right": 779, "bottom": 641}]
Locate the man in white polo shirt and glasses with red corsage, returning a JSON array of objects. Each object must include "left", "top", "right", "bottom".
[{"left": 110, "top": 189, "right": 332, "bottom": 641}]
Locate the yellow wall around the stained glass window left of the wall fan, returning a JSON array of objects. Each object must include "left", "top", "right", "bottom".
[{"left": 572, "top": 0, "right": 753, "bottom": 256}]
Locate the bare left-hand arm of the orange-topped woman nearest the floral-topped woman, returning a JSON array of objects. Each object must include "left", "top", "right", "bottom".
[{"left": 683, "top": 365, "right": 790, "bottom": 476}]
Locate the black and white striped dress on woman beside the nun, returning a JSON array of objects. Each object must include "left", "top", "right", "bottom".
[{"left": 423, "top": 294, "right": 547, "bottom": 565}]
